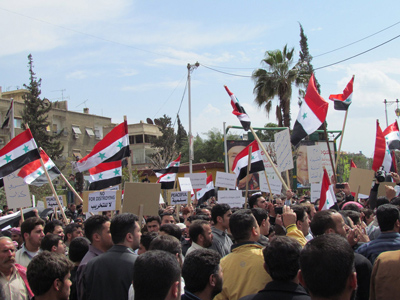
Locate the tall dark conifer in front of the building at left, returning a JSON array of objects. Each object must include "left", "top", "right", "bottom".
[{"left": 21, "top": 54, "right": 64, "bottom": 160}]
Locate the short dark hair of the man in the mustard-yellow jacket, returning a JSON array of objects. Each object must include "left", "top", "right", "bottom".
[{"left": 229, "top": 209, "right": 257, "bottom": 242}]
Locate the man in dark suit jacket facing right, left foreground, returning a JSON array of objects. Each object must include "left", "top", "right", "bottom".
[{"left": 83, "top": 213, "right": 141, "bottom": 300}]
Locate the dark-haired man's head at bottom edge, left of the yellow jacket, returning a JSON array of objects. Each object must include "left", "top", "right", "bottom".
[{"left": 182, "top": 249, "right": 223, "bottom": 300}]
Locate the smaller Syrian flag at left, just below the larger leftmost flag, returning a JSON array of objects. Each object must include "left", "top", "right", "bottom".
[{"left": 18, "top": 149, "right": 61, "bottom": 186}]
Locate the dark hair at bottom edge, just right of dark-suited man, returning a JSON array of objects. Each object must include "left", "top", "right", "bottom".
[{"left": 133, "top": 250, "right": 181, "bottom": 300}]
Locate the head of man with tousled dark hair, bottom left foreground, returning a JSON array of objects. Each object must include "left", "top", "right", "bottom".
[{"left": 26, "top": 251, "right": 74, "bottom": 300}]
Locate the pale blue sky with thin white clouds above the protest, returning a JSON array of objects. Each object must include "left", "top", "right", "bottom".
[{"left": 0, "top": 0, "right": 400, "bottom": 157}]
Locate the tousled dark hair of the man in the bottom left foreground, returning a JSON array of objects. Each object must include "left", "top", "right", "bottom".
[{"left": 26, "top": 251, "right": 74, "bottom": 296}]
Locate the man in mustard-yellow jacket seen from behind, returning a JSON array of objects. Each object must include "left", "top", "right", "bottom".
[{"left": 215, "top": 209, "right": 271, "bottom": 300}]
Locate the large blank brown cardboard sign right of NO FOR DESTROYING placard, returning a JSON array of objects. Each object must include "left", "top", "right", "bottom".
[{"left": 122, "top": 182, "right": 161, "bottom": 216}]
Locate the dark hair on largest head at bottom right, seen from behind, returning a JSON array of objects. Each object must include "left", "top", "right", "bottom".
[{"left": 300, "top": 234, "right": 354, "bottom": 298}]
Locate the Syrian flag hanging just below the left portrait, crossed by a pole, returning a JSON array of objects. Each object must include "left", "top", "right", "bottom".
[{"left": 232, "top": 141, "right": 264, "bottom": 180}]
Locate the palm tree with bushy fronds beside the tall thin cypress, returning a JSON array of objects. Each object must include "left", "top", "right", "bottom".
[{"left": 252, "top": 45, "right": 298, "bottom": 127}]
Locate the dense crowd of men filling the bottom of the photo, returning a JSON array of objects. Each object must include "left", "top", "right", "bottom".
[{"left": 0, "top": 173, "right": 400, "bottom": 300}]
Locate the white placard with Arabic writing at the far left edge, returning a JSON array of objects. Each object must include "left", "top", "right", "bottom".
[{"left": 3, "top": 170, "right": 32, "bottom": 209}]
